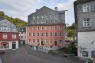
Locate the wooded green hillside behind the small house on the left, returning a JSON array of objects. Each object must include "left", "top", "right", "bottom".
[{"left": 0, "top": 11, "right": 27, "bottom": 27}]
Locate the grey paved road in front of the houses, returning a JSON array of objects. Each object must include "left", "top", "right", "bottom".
[{"left": 1, "top": 46, "right": 82, "bottom": 63}]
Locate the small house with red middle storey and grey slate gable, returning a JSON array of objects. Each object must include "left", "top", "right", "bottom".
[{"left": 0, "top": 19, "right": 19, "bottom": 50}]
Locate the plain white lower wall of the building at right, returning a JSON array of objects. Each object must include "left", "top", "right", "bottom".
[{"left": 78, "top": 32, "right": 95, "bottom": 58}]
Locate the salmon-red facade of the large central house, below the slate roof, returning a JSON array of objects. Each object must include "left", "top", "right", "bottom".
[{"left": 26, "top": 24, "right": 65, "bottom": 47}]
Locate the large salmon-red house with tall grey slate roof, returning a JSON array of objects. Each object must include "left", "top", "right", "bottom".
[{"left": 26, "top": 6, "right": 65, "bottom": 52}]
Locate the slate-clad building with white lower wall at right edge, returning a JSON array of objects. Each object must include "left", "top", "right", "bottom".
[{"left": 74, "top": 0, "right": 95, "bottom": 59}]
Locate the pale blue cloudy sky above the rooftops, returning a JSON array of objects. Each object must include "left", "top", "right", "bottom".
[{"left": 0, "top": 0, "right": 75, "bottom": 25}]
